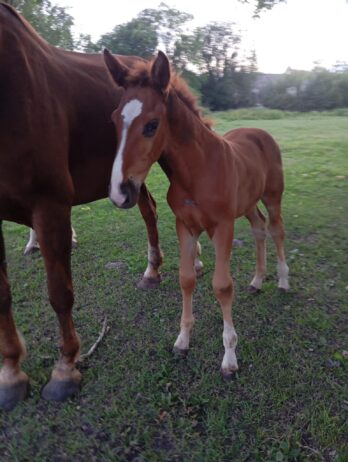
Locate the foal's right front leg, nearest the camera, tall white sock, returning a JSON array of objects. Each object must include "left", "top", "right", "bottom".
[{"left": 212, "top": 223, "right": 238, "bottom": 379}]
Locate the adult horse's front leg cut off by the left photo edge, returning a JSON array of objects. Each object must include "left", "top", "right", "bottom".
[{"left": 0, "top": 221, "right": 29, "bottom": 410}]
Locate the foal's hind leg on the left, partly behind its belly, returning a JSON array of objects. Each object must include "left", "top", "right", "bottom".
[{"left": 246, "top": 206, "right": 266, "bottom": 292}]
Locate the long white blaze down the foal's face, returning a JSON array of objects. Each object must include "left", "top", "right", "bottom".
[{"left": 110, "top": 99, "right": 143, "bottom": 206}]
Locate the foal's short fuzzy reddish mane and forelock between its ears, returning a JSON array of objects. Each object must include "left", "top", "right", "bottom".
[{"left": 125, "top": 61, "right": 212, "bottom": 128}]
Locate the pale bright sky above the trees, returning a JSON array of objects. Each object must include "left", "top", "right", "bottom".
[{"left": 52, "top": 0, "right": 348, "bottom": 73}]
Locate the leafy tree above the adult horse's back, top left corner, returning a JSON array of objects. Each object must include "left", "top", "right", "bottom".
[{"left": 7, "top": 0, "right": 75, "bottom": 50}]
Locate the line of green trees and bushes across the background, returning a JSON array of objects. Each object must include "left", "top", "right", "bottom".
[{"left": 8, "top": 0, "right": 348, "bottom": 111}]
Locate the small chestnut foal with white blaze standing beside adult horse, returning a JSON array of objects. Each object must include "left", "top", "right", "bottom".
[{"left": 104, "top": 50, "right": 289, "bottom": 378}]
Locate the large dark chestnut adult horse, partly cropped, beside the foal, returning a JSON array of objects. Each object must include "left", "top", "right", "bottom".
[{"left": 0, "top": 3, "right": 162, "bottom": 409}]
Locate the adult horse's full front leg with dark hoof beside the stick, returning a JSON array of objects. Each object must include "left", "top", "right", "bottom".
[{"left": 33, "top": 201, "right": 81, "bottom": 401}]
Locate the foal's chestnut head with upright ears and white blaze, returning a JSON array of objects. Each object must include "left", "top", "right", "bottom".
[{"left": 104, "top": 50, "right": 170, "bottom": 208}]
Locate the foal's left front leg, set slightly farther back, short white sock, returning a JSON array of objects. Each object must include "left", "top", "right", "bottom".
[{"left": 174, "top": 219, "right": 197, "bottom": 355}]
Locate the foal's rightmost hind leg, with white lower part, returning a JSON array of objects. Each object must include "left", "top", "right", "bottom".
[{"left": 262, "top": 196, "right": 290, "bottom": 291}]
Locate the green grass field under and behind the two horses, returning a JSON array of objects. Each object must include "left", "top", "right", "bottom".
[{"left": 0, "top": 111, "right": 348, "bottom": 462}]
